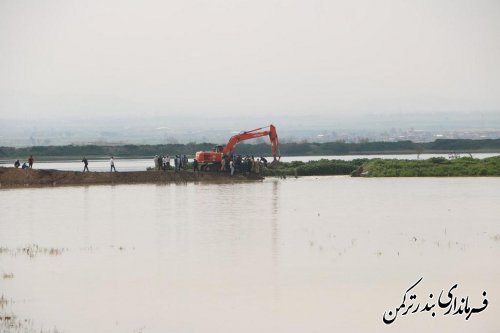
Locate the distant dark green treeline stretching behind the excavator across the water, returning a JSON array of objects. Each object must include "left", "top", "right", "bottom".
[{"left": 0, "top": 139, "right": 500, "bottom": 160}]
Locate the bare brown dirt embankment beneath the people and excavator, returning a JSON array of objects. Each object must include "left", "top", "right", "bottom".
[{"left": 0, "top": 167, "right": 262, "bottom": 188}]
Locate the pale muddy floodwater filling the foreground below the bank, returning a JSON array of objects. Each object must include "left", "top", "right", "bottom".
[{"left": 0, "top": 177, "right": 500, "bottom": 333}]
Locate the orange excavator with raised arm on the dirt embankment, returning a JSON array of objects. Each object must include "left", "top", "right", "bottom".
[{"left": 195, "top": 125, "right": 281, "bottom": 171}]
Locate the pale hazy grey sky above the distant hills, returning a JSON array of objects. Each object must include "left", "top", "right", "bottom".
[{"left": 0, "top": 0, "right": 500, "bottom": 117}]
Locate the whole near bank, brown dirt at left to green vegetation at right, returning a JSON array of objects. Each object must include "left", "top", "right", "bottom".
[{"left": 0, "top": 156, "right": 500, "bottom": 188}]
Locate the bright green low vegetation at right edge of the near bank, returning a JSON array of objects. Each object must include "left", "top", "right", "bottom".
[{"left": 362, "top": 156, "right": 500, "bottom": 177}]
